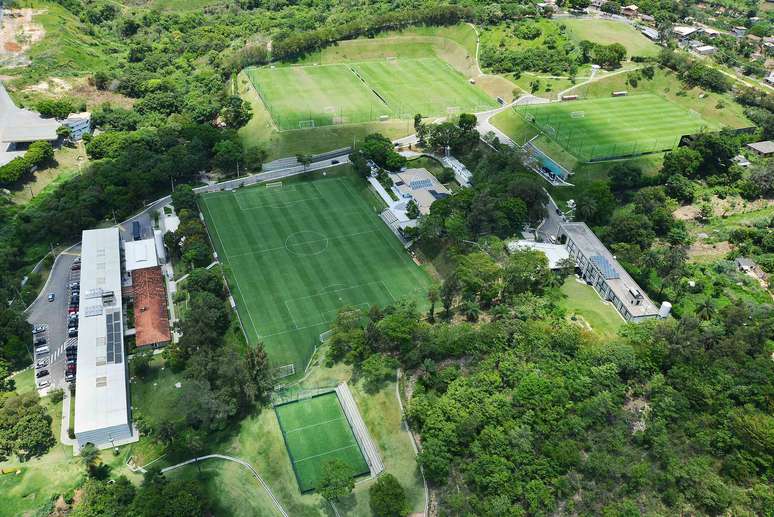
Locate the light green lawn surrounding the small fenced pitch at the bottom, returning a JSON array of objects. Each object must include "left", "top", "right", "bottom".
[{"left": 167, "top": 358, "right": 424, "bottom": 517}]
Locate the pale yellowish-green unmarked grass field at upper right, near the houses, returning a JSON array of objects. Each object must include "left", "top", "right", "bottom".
[{"left": 562, "top": 18, "right": 659, "bottom": 57}]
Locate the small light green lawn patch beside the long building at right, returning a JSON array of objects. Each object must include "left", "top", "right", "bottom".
[{"left": 559, "top": 276, "right": 625, "bottom": 339}]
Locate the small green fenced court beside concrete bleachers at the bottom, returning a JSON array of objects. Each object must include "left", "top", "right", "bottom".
[{"left": 274, "top": 392, "right": 370, "bottom": 492}]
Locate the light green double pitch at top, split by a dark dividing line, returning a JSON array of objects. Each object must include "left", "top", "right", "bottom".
[{"left": 246, "top": 57, "right": 497, "bottom": 129}]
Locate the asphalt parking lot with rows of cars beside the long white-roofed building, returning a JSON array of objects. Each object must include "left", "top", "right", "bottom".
[{"left": 27, "top": 246, "right": 80, "bottom": 395}]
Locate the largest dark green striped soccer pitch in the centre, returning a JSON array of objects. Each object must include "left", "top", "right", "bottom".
[{"left": 199, "top": 176, "right": 430, "bottom": 374}]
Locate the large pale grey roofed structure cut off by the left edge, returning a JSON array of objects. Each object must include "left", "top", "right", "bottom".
[{"left": 0, "top": 82, "right": 60, "bottom": 166}]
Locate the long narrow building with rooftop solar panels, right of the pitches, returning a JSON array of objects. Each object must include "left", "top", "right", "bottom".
[{"left": 559, "top": 223, "right": 668, "bottom": 323}]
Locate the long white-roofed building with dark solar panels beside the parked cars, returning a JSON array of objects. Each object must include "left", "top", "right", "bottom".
[{"left": 75, "top": 228, "right": 138, "bottom": 448}]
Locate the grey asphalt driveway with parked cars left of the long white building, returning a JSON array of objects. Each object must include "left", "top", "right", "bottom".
[{"left": 26, "top": 245, "right": 81, "bottom": 395}]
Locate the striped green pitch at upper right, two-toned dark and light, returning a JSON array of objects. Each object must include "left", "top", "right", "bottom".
[{"left": 517, "top": 94, "right": 715, "bottom": 161}]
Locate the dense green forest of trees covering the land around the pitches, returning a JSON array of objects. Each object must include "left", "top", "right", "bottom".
[{"left": 0, "top": 0, "right": 774, "bottom": 516}]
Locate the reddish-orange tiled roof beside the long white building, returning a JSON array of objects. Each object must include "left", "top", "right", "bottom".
[{"left": 132, "top": 267, "right": 172, "bottom": 346}]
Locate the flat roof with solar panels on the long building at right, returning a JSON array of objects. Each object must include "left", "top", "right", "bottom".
[{"left": 561, "top": 223, "right": 658, "bottom": 317}]
